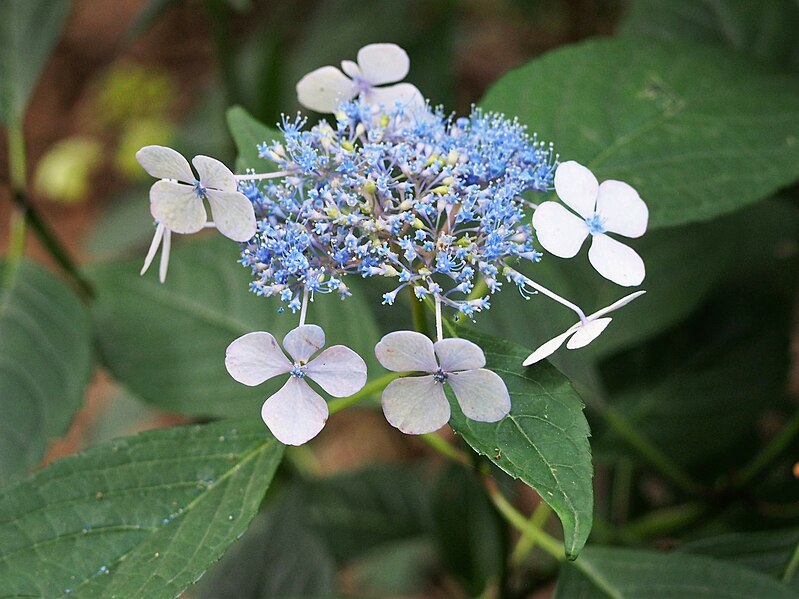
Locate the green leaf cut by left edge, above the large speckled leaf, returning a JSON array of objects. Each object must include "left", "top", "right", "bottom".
[{"left": 0, "top": 260, "right": 92, "bottom": 484}]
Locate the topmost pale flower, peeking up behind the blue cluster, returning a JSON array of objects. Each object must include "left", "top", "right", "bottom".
[{"left": 297, "top": 44, "right": 424, "bottom": 113}]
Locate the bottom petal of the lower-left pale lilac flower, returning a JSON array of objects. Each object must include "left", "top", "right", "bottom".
[{"left": 261, "top": 376, "right": 329, "bottom": 445}]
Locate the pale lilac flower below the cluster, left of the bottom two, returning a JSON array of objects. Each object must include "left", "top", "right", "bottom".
[{"left": 225, "top": 324, "right": 366, "bottom": 445}]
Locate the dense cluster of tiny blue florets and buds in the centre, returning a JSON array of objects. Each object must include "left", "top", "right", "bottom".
[{"left": 240, "top": 101, "right": 557, "bottom": 317}]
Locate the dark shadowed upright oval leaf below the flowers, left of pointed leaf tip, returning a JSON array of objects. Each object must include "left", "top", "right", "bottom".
[{"left": 433, "top": 464, "right": 506, "bottom": 597}]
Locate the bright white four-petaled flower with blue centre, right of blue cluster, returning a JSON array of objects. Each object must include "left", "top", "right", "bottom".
[{"left": 533, "top": 160, "right": 649, "bottom": 287}]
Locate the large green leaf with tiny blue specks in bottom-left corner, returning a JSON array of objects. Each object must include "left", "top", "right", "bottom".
[{"left": 0, "top": 418, "right": 283, "bottom": 599}]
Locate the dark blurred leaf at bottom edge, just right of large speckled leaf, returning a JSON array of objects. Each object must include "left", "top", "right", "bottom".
[{"left": 200, "top": 495, "right": 337, "bottom": 599}]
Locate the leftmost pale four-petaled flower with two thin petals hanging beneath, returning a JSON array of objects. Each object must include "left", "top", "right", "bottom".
[{"left": 136, "top": 146, "right": 256, "bottom": 283}]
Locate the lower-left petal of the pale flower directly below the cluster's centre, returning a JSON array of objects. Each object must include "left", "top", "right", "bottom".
[{"left": 383, "top": 376, "right": 450, "bottom": 435}]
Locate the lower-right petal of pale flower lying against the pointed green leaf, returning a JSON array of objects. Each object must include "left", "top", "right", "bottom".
[{"left": 447, "top": 368, "right": 510, "bottom": 422}]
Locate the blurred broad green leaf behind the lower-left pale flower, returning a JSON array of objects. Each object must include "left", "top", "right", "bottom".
[{"left": 90, "top": 236, "right": 379, "bottom": 417}]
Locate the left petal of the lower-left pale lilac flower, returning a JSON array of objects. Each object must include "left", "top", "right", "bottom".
[{"left": 225, "top": 331, "right": 292, "bottom": 387}]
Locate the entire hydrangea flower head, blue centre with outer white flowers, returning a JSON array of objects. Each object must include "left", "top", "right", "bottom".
[{"left": 137, "top": 44, "right": 648, "bottom": 445}]
